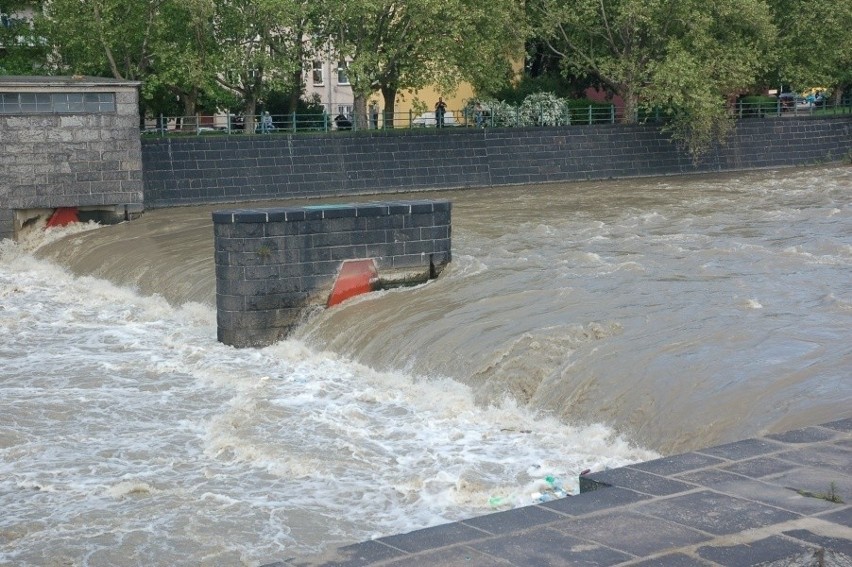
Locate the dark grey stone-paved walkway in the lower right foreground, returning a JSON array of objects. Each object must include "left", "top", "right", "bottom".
[{"left": 267, "top": 418, "right": 852, "bottom": 567}]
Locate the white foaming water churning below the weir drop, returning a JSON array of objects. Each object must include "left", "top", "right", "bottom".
[{"left": 0, "top": 235, "right": 655, "bottom": 566}]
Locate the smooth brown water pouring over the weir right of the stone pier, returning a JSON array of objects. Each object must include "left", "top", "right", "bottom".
[{"left": 297, "top": 166, "right": 852, "bottom": 454}]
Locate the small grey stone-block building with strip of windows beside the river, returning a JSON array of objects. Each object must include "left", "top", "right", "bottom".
[{"left": 0, "top": 76, "right": 143, "bottom": 239}]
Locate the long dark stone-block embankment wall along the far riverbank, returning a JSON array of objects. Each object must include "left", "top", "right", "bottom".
[{"left": 142, "top": 115, "right": 852, "bottom": 208}]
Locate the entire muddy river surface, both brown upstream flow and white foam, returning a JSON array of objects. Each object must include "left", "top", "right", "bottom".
[{"left": 0, "top": 167, "right": 852, "bottom": 565}]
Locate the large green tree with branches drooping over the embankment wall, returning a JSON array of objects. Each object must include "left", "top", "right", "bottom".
[{"left": 528, "top": 0, "right": 776, "bottom": 156}]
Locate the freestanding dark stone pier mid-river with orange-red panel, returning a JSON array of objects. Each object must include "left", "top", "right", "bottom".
[{"left": 213, "top": 200, "right": 451, "bottom": 347}]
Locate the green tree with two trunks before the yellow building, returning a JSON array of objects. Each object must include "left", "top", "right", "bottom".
[{"left": 322, "top": 0, "right": 523, "bottom": 128}]
